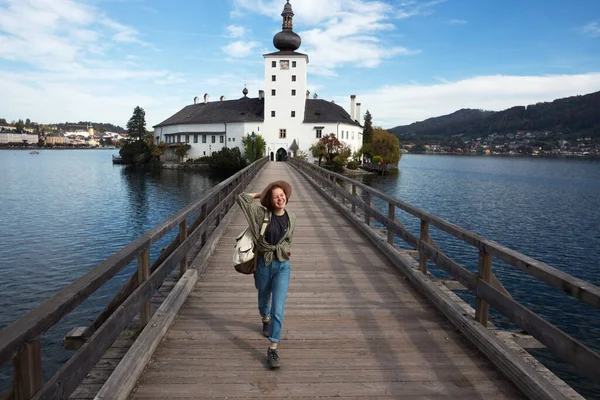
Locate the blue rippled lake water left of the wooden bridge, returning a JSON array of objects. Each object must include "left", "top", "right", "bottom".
[{"left": 0, "top": 150, "right": 222, "bottom": 393}]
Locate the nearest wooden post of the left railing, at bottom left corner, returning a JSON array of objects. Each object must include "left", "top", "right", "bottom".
[{"left": 13, "top": 337, "right": 44, "bottom": 400}]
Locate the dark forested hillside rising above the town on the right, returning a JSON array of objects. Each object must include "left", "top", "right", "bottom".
[{"left": 388, "top": 92, "right": 600, "bottom": 137}]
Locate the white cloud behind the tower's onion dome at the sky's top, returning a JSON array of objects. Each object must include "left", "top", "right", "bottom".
[{"left": 233, "top": 0, "right": 422, "bottom": 76}]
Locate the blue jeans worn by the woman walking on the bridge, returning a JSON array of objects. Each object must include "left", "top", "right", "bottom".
[{"left": 254, "top": 257, "right": 290, "bottom": 343}]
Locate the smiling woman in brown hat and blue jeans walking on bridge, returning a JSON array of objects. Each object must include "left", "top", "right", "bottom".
[{"left": 237, "top": 181, "right": 296, "bottom": 369}]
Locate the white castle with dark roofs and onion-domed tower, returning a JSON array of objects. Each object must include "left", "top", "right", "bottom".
[{"left": 154, "top": 0, "right": 362, "bottom": 160}]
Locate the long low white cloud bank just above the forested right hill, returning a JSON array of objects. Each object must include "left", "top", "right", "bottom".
[{"left": 334, "top": 72, "right": 600, "bottom": 128}]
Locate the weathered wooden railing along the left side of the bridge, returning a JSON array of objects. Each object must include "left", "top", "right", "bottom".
[{"left": 0, "top": 158, "right": 268, "bottom": 400}]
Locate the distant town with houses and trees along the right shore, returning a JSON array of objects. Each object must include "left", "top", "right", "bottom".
[{"left": 398, "top": 131, "right": 600, "bottom": 156}]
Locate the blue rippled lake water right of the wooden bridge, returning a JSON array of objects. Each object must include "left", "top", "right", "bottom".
[{"left": 352, "top": 155, "right": 600, "bottom": 399}]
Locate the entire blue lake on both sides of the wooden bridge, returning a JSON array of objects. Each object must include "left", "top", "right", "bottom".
[{"left": 0, "top": 150, "right": 600, "bottom": 398}]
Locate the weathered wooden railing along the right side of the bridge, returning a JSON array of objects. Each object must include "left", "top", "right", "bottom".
[{"left": 290, "top": 159, "right": 600, "bottom": 383}]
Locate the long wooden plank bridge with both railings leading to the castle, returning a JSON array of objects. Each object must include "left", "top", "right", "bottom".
[{"left": 0, "top": 158, "right": 600, "bottom": 399}]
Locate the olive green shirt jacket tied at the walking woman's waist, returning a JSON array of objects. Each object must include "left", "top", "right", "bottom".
[{"left": 237, "top": 193, "right": 296, "bottom": 265}]
